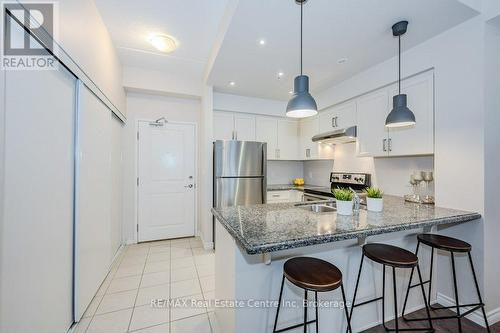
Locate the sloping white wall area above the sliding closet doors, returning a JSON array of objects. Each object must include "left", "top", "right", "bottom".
[{"left": 58, "top": 0, "right": 126, "bottom": 114}]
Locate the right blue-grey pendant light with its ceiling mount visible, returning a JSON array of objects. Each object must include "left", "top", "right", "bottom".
[{"left": 385, "top": 21, "right": 416, "bottom": 128}]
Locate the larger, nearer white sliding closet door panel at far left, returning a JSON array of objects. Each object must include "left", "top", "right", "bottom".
[{"left": 0, "top": 66, "right": 76, "bottom": 333}]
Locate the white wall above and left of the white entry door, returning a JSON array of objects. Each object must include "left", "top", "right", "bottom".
[{"left": 123, "top": 93, "right": 201, "bottom": 243}]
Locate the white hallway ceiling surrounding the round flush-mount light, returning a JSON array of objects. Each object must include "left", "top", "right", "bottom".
[{"left": 95, "top": 0, "right": 227, "bottom": 80}]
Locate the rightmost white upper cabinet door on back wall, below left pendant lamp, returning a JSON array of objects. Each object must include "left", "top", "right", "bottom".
[{"left": 277, "top": 119, "right": 300, "bottom": 160}]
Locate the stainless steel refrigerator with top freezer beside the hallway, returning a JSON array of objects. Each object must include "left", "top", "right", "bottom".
[{"left": 213, "top": 140, "right": 267, "bottom": 207}]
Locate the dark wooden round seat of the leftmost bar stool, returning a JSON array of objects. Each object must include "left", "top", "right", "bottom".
[{"left": 283, "top": 257, "right": 342, "bottom": 291}]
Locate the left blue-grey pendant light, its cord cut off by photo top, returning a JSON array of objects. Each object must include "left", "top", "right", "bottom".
[{"left": 286, "top": 0, "right": 318, "bottom": 118}]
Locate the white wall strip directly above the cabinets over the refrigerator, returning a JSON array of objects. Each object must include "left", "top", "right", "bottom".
[{"left": 213, "top": 93, "right": 287, "bottom": 117}]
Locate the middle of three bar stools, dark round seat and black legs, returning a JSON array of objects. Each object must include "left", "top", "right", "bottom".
[{"left": 350, "top": 243, "right": 434, "bottom": 332}]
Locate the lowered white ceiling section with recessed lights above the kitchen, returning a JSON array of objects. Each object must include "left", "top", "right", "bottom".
[{"left": 209, "top": 0, "right": 477, "bottom": 100}]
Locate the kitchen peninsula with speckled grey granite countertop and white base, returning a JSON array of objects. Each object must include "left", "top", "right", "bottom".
[{"left": 212, "top": 196, "right": 481, "bottom": 333}]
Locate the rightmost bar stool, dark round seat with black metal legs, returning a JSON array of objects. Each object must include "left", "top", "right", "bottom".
[{"left": 403, "top": 234, "right": 490, "bottom": 332}]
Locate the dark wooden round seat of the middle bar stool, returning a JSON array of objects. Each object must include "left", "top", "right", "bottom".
[{"left": 363, "top": 243, "right": 418, "bottom": 268}]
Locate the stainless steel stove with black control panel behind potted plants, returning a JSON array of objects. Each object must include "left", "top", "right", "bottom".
[{"left": 304, "top": 172, "right": 371, "bottom": 201}]
